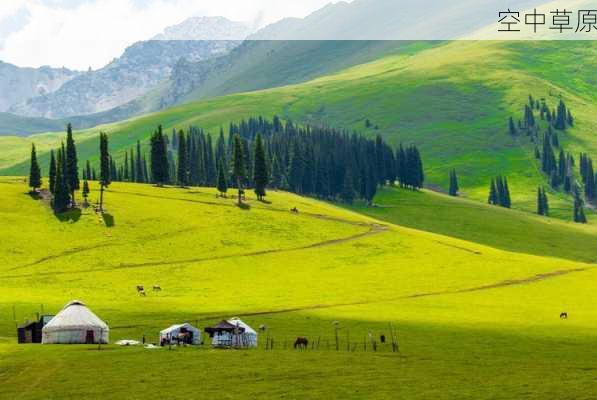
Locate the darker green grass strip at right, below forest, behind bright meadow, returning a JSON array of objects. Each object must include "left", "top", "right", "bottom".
[{"left": 350, "top": 187, "right": 597, "bottom": 263}]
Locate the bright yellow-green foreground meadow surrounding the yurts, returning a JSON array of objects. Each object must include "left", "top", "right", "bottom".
[{"left": 0, "top": 178, "right": 597, "bottom": 399}]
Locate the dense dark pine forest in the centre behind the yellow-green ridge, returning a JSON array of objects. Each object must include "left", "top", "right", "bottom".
[{"left": 106, "top": 117, "right": 425, "bottom": 203}]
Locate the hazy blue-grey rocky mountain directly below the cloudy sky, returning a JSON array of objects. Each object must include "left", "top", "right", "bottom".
[{"left": 7, "top": 17, "right": 250, "bottom": 118}]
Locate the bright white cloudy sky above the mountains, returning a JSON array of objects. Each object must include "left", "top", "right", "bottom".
[{"left": 0, "top": 0, "right": 334, "bottom": 70}]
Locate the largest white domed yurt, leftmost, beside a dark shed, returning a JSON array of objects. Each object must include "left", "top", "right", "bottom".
[{"left": 42, "top": 300, "right": 110, "bottom": 344}]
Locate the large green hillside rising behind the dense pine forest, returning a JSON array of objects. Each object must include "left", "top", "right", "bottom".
[{"left": 0, "top": 42, "right": 597, "bottom": 219}]
